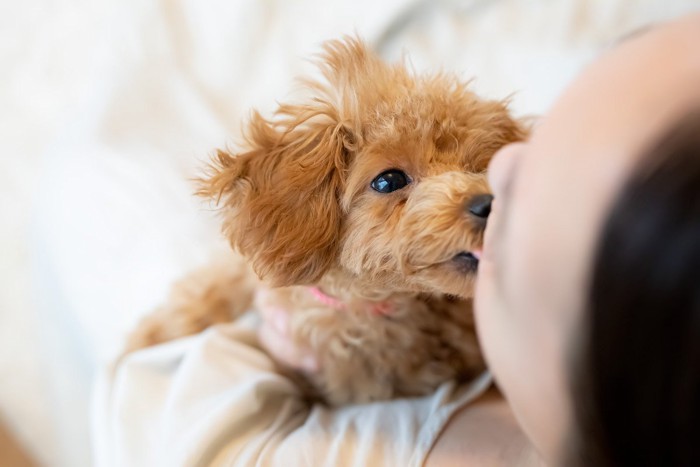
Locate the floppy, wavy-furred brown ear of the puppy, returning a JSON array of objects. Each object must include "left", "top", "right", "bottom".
[{"left": 199, "top": 107, "right": 352, "bottom": 286}]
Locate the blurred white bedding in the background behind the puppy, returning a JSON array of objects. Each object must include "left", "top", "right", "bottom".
[{"left": 0, "top": 0, "right": 700, "bottom": 467}]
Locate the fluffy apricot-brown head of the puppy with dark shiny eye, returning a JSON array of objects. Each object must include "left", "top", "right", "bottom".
[{"left": 200, "top": 39, "right": 524, "bottom": 297}]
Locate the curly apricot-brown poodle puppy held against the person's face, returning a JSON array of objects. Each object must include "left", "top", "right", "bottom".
[{"left": 128, "top": 38, "right": 526, "bottom": 405}]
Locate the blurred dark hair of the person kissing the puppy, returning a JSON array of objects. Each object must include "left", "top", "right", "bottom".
[{"left": 566, "top": 111, "right": 700, "bottom": 467}]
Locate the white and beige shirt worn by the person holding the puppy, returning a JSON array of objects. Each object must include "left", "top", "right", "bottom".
[{"left": 92, "top": 314, "right": 491, "bottom": 467}]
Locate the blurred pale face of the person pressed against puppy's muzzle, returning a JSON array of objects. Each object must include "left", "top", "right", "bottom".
[{"left": 476, "top": 15, "right": 700, "bottom": 464}]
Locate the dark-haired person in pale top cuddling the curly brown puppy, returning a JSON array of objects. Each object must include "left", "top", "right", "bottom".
[{"left": 94, "top": 14, "right": 700, "bottom": 467}]
